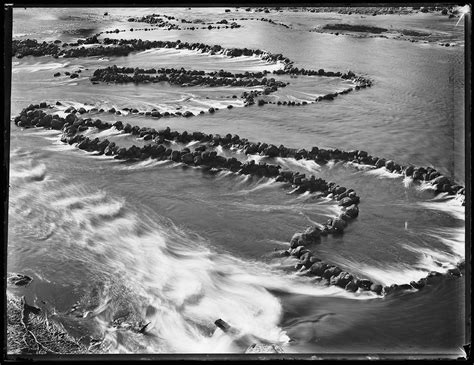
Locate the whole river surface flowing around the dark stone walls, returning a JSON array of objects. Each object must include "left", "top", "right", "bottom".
[{"left": 7, "top": 8, "right": 465, "bottom": 356}]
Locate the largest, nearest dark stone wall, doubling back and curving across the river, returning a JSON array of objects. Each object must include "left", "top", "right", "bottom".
[{"left": 14, "top": 102, "right": 465, "bottom": 295}]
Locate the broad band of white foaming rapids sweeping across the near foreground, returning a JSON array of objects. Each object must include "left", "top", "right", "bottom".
[{"left": 10, "top": 161, "right": 386, "bottom": 353}]
